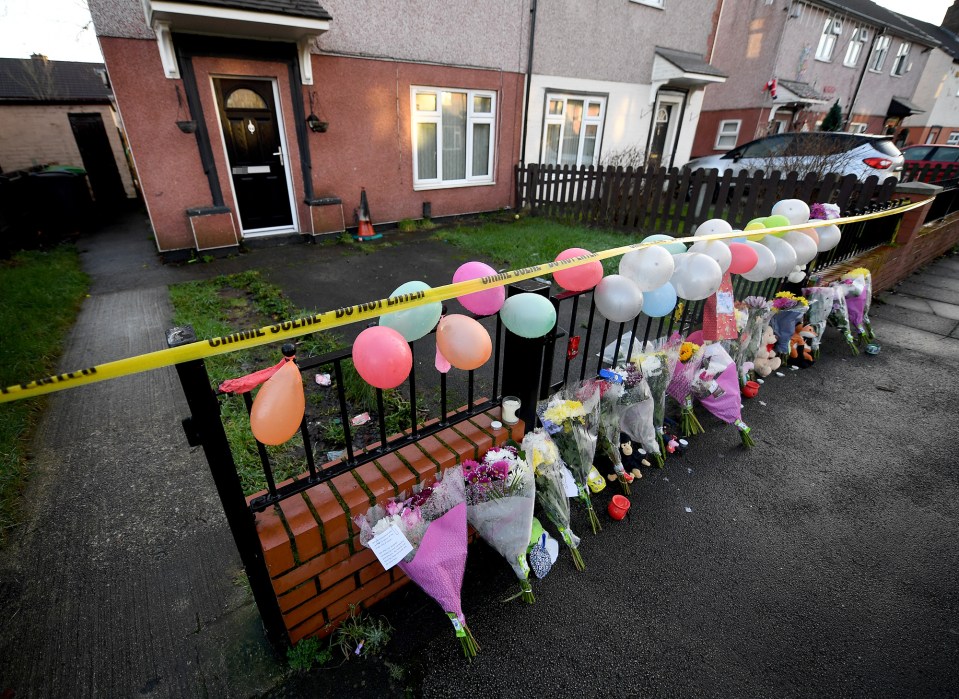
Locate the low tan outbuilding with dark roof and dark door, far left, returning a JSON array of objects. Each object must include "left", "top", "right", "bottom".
[{"left": 0, "top": 54, "right": 136, "bottom": 205}]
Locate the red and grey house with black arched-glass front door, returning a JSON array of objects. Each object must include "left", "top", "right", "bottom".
[{"left": 90, "top": 0, "right": 529, "bottom": 257}]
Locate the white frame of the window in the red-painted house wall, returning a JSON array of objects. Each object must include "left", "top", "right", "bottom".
[{"left": 410, "top": 85, "right": 497, "bottom": 191}]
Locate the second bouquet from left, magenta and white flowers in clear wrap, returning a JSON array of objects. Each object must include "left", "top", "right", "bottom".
[{"left": 462, "top": 446, "right": 536, "bottom": 604}]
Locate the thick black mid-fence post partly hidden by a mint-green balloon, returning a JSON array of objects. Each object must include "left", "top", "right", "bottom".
[{"left": 503, "top": 279, "right": 559, "bottom": 430}]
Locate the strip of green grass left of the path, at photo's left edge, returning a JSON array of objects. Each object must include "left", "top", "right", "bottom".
[{"left": 0, "top": 245, "right": 89, "bottom": 544}]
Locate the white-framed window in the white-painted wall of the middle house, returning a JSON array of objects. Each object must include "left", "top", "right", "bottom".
[{"left": 542, "top": 93, "right": 606, "bottom": 166}]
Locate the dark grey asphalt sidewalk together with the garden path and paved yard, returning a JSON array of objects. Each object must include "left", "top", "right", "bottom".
[{"left": 0, "top": 215, "right": 959, "bottom": 699}]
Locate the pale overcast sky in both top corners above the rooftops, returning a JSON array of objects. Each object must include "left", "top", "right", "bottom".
[{"left": 0, "top": 0, "right": 952, "bottom": 62}]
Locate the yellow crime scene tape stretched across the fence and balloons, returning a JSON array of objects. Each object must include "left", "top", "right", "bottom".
[{"left": 0, "top": 197, "right": 935, "bottom": 403}]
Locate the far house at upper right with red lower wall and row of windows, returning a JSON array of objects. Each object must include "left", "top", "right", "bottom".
[{"left": 693, "top": 0, "right": 939, "bottom": 155}]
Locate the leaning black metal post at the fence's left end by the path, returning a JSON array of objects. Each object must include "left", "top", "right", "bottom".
[{"left": 167, "top": 325, "right": 289, "bottom": 649}]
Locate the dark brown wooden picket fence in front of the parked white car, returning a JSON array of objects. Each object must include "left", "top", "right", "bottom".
[{"left": 516, "top": 164, "right": 898, "bottom": 236}]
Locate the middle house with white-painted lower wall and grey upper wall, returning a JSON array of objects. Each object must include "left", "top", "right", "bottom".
[{"left": 524, "top": 0, "right": 729, "bottom": 172}]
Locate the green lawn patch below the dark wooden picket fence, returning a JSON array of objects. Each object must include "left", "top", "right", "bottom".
[{"left": 436, "top": 216, "right": 642, "bottom": 274}]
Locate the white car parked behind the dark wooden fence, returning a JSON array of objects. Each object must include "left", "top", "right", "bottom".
[{"left": 685, "top": 131, "right": 904, "bottom": 180}]
